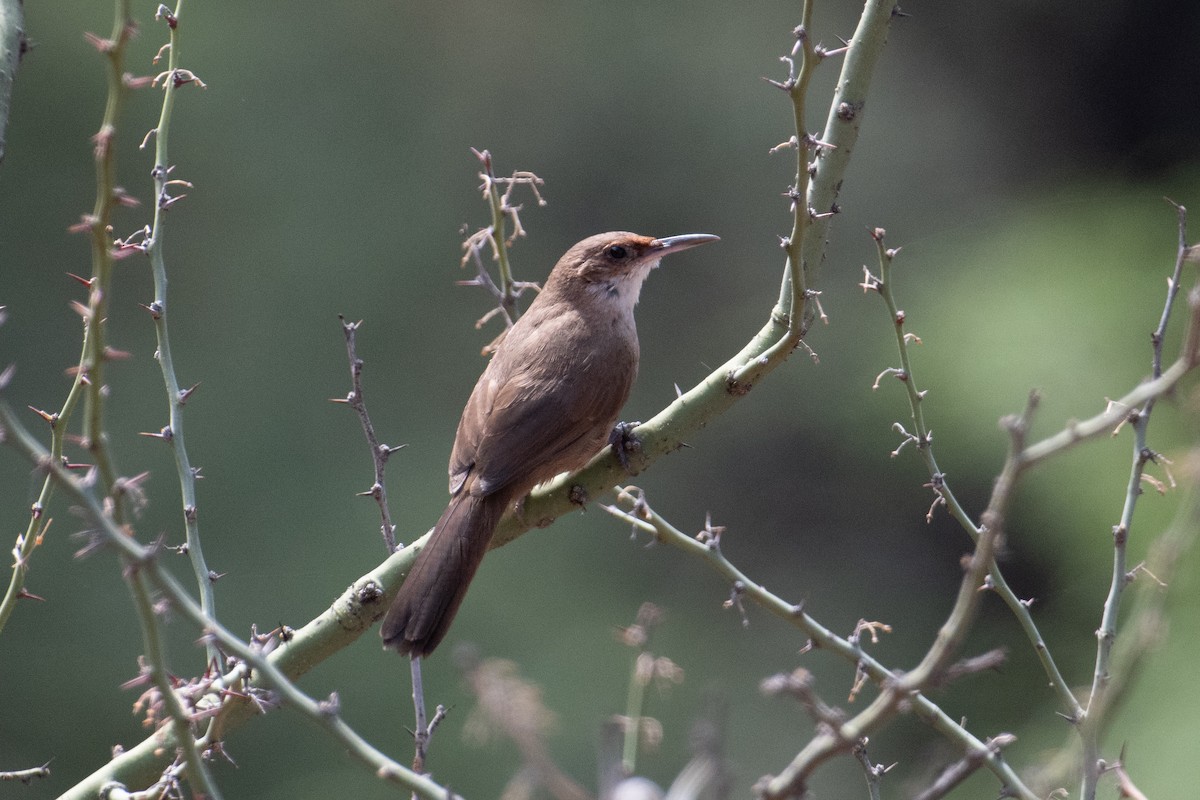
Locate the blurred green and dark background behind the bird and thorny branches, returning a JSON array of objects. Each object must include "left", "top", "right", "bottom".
[{"left": 0, "top": 0, "right": 1200, "bottom": 798}]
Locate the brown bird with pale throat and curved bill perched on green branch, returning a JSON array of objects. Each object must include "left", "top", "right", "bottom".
[{"left": 382, "top": 231, "right": 718, "bottom": 657}]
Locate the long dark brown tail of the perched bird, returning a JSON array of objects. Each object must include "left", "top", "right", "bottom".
[{"left": 380, "top": 492, "right": 508, "bottom": 656}]
